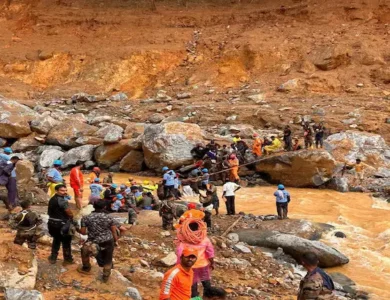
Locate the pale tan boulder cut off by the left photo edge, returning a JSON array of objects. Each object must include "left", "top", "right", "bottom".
[{"left": 0, "top": 100, "right": 38, "bottom": 138}]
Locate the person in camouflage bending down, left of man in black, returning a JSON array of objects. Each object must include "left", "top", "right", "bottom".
[{"left": 10, "top": 200, "right": 43, "bottom": 249}]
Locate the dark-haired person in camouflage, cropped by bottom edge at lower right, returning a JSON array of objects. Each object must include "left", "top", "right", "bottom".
[{"left": 297, "top": 252, "right": 338, "bottom": 300}]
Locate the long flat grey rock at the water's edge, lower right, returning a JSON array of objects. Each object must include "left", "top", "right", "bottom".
[{"left": 237, "top": 230, "right": 349, "bottom": 268}]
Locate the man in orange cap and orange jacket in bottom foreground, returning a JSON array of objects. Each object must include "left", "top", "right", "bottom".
[{"left": 159, "top": 248, "right": 198, "bottom": 300}]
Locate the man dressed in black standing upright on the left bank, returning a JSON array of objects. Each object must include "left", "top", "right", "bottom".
[{"left": 47, "top": 184, "right": 73, "bottom": 265}]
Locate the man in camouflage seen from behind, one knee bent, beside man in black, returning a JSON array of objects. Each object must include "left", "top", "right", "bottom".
[{"left": 77, "top": 201, "right": 120, "bottom": 282}]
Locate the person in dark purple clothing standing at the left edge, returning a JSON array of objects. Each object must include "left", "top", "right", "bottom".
[{"left": 0, "top": 156, "right": 20, "bottom": 211}]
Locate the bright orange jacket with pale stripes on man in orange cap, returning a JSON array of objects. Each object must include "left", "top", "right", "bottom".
[{"left": 160, "top": 264, "right": 194, "bottom": 300}]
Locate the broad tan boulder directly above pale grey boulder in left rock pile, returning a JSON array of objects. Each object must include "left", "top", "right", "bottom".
[{"left": 46, "top": 120, "right": 98, "bottom": 148}]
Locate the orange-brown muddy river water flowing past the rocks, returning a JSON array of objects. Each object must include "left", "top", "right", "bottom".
[{"left": 71, "top": 174, "right": 390, "bottom": 299}]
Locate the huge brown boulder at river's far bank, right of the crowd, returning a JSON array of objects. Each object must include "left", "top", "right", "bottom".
[{"left": 256, "top": 150, "right": 336, "bottom": 187}]
